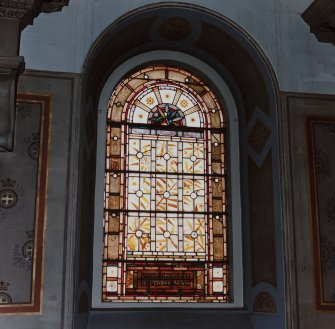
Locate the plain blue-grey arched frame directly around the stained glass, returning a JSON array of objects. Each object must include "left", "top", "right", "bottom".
[{"left": 92, "top": 51, "right": 243, "bottom": 309}]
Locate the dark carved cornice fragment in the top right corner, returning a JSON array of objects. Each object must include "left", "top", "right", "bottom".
[{"left": 302, "top": 0, "right": 335, "bottom": 45}]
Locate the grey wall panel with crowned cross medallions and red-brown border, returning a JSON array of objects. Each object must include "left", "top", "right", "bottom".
[{"left": 0, "top": 94, "right": 51, "bottom": 313}]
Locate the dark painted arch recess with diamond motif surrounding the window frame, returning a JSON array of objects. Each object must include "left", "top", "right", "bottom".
[{"left": 77, "top": 4, "right": 285, "bottom": 328}]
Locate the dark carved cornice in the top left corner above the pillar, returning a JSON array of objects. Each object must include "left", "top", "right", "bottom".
[{"left": 0, "top": 0, "right": 69, "bottom": 30}]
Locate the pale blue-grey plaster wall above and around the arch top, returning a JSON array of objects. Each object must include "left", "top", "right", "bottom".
[{"left": 21, "top": 0, "right": 335, "bottom": 93}]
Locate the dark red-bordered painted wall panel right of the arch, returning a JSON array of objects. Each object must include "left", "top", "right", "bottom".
[{"left": 307, "top": 117, "right": 335, "bottom": 311}]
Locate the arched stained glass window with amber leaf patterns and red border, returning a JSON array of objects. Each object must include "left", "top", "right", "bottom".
[{"left": 102, "top": 66, "right": 229, "bottom": 303}]
